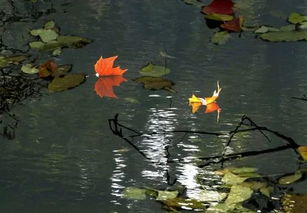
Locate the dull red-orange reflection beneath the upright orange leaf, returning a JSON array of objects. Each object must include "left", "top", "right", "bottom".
[{"left": 95, "top": 75, "right": 127, "bottom": 98}]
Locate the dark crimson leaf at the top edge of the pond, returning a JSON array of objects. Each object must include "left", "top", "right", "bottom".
[{"left": 202, "top": 0, "right": 234, "bottom": 15}]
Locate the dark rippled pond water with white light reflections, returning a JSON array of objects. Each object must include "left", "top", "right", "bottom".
[{"left": 0, "top": 0, "right": 307, "bottom": 213}]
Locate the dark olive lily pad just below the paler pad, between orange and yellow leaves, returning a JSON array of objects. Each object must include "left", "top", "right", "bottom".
[{"left": 134, "top": 76, "right": 175, "bottom": 92}]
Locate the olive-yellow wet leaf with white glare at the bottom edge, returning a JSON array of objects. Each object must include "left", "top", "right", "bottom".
[{"left": 162, "top": 197, "right": 205, "bottom": 210}]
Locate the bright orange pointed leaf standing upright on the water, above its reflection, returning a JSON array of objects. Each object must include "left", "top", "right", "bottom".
[{"left": 95, "top": 56, "right": 127, "bottom": 76}]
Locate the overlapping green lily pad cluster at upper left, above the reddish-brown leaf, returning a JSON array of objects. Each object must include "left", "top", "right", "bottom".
[{"left": 29, "top": 21, "right": 92, "bottom": 55}]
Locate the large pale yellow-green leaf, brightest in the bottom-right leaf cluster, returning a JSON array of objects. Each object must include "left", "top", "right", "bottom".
[{"left": 225, "top": 185, "right": 253, "bottom": 205}]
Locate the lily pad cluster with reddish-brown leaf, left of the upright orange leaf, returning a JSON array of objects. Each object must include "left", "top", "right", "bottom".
[{"left": 21, "top": 60, "right": 85, "bottom": 92}]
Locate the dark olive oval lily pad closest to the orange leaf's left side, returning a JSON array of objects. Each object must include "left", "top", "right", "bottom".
[{"left": 48, "top": 73, "right": 85, "bottom": 92}]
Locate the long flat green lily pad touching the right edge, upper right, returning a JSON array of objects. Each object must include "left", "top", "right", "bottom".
[{"left": 260, "top": 31, "right": 307, "bottom": 42}]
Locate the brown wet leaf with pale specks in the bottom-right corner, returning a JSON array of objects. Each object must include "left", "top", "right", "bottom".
[{"left": 282, "top": 194, "right": 307, "bottom": 213}]
